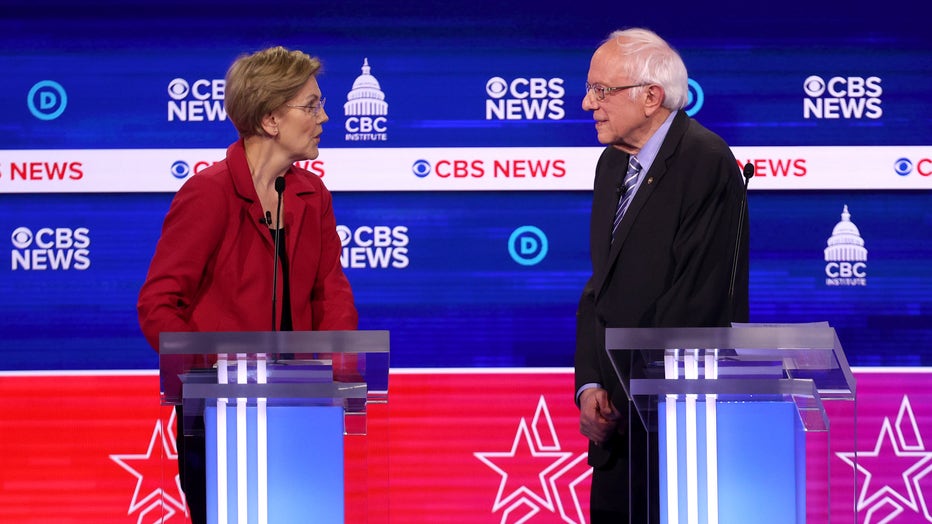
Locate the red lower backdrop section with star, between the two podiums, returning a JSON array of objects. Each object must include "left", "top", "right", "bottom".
[{"left": 389, "top": 371, "right": 590, "bottom": 524}]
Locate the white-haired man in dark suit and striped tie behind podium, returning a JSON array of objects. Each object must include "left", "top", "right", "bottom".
[{"left": 575, "top": 29, "right": 748, "bottom": 524}]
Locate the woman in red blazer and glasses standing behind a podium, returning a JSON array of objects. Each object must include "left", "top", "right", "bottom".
[{"left": 137, "top": 47, "right": 357, "bottom": 523}]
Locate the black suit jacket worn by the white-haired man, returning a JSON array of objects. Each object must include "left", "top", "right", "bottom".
[{"left": 575, "top": 111, "right": 748, "bottom": 467}]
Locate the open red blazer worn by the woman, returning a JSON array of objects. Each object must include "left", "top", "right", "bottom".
[{"left": 137, "top": 140, "right": 358, "bottom": 350}]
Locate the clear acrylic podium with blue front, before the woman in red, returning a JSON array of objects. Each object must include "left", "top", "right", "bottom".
[{"left": 159, "top": 331, "right": 389, "bottom": 524}]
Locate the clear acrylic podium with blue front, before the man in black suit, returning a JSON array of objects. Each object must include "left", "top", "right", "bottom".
[{"left": 605, "top": 323, "right": 855, "bottom": 524}]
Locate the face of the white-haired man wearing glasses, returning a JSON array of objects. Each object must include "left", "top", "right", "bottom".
[{"left": 582, "top": 42, "right": 647, "bottom": 151}]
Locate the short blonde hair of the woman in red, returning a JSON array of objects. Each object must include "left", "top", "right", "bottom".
[{"left": 224, "top": 46, "right": 320, "bottom": 137}]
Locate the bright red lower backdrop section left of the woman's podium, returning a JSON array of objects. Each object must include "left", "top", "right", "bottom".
[{"left": 0, "top": 375, "right": 181, "bottom": 524}]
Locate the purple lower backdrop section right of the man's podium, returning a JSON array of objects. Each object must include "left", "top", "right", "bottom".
[{"left": 824, "top": 368, "right": 932, "bottom": 524}]
